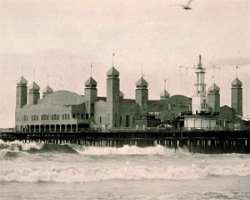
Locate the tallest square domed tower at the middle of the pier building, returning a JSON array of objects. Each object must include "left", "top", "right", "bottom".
[{"left": 107, "top": 67, "right": 120, "bottom": 128}]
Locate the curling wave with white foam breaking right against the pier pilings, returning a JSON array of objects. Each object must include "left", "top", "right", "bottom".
[{"left": 0, "top": 140, "right": 182, "bottom": 158}]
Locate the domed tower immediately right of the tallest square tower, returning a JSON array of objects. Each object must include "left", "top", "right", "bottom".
[{"left": 135, "top": 76, "right": 148, "bottom": 111}]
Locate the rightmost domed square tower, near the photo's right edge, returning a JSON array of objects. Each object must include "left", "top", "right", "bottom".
[{"left": 231, "top": 78, "right": 243, "bottom": 116}]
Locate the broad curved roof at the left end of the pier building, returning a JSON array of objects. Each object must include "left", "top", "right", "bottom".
[{"left": 41, "top": 90, "right": 84, "bottom": 106}]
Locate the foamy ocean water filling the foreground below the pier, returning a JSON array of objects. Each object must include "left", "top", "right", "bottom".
[{"left": 0, "top": 140, "right": 250, "bottom": 200}]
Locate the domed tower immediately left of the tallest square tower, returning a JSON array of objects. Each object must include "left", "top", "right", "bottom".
[{"left": 84, "top": 76, "right": 97, "bottom": 118}]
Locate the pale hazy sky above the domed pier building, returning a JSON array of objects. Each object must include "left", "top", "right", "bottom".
[{"left": 0, "top": 0, "right": 250, "bottom": 127}]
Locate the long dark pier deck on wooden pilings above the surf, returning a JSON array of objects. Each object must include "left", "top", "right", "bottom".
[{"left": 0, "top": 130, "right": 250, "bottom": 153}]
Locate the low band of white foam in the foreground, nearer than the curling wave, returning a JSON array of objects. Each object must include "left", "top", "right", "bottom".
[{"left": 0, "top": 159, "right": 250, "bottom": 183}]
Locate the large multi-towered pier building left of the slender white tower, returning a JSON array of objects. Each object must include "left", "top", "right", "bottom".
[{"left": 15, "top": 67, "right": 192, "bottom": 132}]
